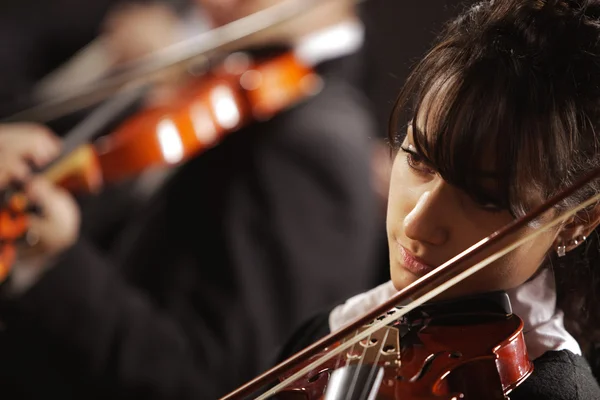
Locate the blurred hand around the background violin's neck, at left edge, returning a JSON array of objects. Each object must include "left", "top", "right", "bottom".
[{"left": 0, "top": 123, "right": 80, "bottom": 264}]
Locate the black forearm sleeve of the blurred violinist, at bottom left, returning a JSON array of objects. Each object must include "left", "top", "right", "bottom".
[{"left": 0, "top": 242, "right": 216, "bottom": 399}]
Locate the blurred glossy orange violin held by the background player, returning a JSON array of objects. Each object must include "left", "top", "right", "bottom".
[{"left": 0, "top": 52, "right": 322, "bottom": 282}]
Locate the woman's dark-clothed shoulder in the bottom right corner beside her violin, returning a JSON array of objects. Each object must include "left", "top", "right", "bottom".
[{"left": 510, "top": 350, "right": 600, "bottom": 400}]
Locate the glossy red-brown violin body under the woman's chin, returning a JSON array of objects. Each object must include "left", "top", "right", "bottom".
[{"left": 276, "top": 311, "right": 533, "bottom": 400}]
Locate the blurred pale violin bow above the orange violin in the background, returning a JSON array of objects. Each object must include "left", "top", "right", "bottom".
[{"left": 0, "top": 0, "right": 366, "bottom": 123}]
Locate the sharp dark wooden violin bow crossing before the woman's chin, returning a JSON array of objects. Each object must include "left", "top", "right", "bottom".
[{"left": 221, "top": 167, "right": 600, "bottom": 400}]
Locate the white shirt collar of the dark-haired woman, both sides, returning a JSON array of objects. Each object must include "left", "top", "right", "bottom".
[{"left": 329, "top": 270, "right": 581, "bottom": 360}]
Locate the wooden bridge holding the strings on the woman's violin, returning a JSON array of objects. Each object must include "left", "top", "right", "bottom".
[{"left": 345, "top": 326, "right": 400, "bottom": 366}]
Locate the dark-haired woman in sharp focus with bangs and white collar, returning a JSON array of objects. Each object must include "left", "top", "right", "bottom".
[{"left": 276, "top": 0, "right": 600, "bottom": 400}]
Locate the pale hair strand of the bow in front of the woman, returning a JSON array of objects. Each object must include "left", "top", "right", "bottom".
[{"left": 257, "top": 189, "right": 600, "bottom": 400}]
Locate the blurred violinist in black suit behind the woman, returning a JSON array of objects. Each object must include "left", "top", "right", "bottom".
[{"left": 0, "top": 0, "right": 379, "bottom": 399}]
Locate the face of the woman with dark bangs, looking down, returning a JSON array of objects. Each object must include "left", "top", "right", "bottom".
[{"left": 387, "top": 127, "right": 557, "bottom": 298}]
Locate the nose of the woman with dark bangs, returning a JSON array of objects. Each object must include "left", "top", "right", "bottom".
[{"left": 403, "top": 184, "right": 451, "bottom": 246}]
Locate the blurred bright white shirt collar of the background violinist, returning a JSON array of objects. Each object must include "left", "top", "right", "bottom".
[{"left": 294, "top": 20, "right": 365, "bottom": 66}]
